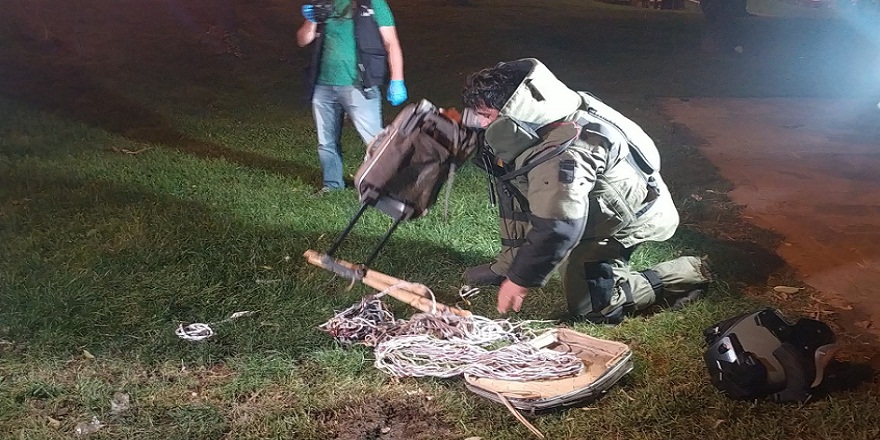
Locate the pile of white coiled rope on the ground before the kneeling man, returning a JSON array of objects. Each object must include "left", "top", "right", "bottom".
[{"left": 319, "top": 282, "right": 584, "bottom": 380}]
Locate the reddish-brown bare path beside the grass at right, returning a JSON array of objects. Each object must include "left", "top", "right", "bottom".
[{"left": 661, "top": 99, "right": 880, "bottom": 337}]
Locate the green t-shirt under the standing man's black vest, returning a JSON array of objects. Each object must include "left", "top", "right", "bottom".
[{"left": 318, "top": 0, "right": 394, "bottom": 86}]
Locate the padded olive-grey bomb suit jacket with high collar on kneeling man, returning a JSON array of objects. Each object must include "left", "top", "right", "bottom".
[{"left": 485, "top": 58, "right": 679, "bottom": 287}]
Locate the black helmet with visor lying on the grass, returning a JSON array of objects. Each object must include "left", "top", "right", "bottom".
[{"left": 703, "top": 308, "right": 838, "bottom": 402}]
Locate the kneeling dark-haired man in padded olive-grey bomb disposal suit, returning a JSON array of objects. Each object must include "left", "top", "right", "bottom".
[{"left": 462, "top": 58, "right": 710, "bottom": 324}]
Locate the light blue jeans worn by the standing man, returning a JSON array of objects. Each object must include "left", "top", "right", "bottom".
[{"left": 312, "top": 85, "right": 382, "bottom": 189}]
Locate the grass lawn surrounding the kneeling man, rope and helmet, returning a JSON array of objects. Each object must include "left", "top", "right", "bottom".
[{"left": 0, "top": 0, "right": 880, "bottom": 440}]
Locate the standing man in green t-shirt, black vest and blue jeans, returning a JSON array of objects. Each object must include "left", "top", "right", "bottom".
[{"left": 296, "top": 0, "right": 407, "bottom": 195}]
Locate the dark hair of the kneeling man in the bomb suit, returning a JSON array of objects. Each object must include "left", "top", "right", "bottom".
[{"left": 461, "top": 62, "right": 529, "bottom": 110}]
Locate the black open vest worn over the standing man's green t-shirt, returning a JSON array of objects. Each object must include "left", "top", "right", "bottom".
[{"left": 306, "top": 0, "right": 388, "bottom": 101}]
